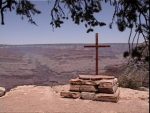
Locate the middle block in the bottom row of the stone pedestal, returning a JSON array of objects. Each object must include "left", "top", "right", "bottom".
[{"left": 81, "top": 92, "right": 95, "bottom": 100}]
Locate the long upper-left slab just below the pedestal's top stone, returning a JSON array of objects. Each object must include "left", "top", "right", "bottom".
[{"left": 70, "top": 78, "right": 97, "bottom": 86}]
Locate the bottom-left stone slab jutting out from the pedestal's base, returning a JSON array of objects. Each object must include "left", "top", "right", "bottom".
[{"left": 60, "top": 91, "right": 80, "bottom": 99}]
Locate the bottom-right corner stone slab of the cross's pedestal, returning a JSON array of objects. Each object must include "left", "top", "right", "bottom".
[{"left": 93, "top": 89, "right": 120, "bottom": 102}]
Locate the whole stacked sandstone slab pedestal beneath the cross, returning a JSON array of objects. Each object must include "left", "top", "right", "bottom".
[{"left": 60, "top": 75, "right": 120, "bottom": 102}]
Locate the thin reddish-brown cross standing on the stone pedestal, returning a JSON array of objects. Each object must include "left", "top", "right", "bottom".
[{"left": 84, "top": 33, "right": 110, "bottom": 75}]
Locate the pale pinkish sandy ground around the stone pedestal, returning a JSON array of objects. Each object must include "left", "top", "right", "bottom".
[{"left": 0, "top": 85, "right": 149, "bottom": 113}]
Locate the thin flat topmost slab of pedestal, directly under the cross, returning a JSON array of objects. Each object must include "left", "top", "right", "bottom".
[{"left": 79, "top": 75, "right": 115, "bottom": 80}]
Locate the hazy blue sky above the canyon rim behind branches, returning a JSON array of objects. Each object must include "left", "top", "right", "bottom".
[{"left": 0, "top": 1, "right": 144, "bottom": 44}]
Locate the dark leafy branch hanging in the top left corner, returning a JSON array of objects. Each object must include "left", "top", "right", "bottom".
[{"left": 0, "top": 0, "right": 41, "bottom": 25}]
